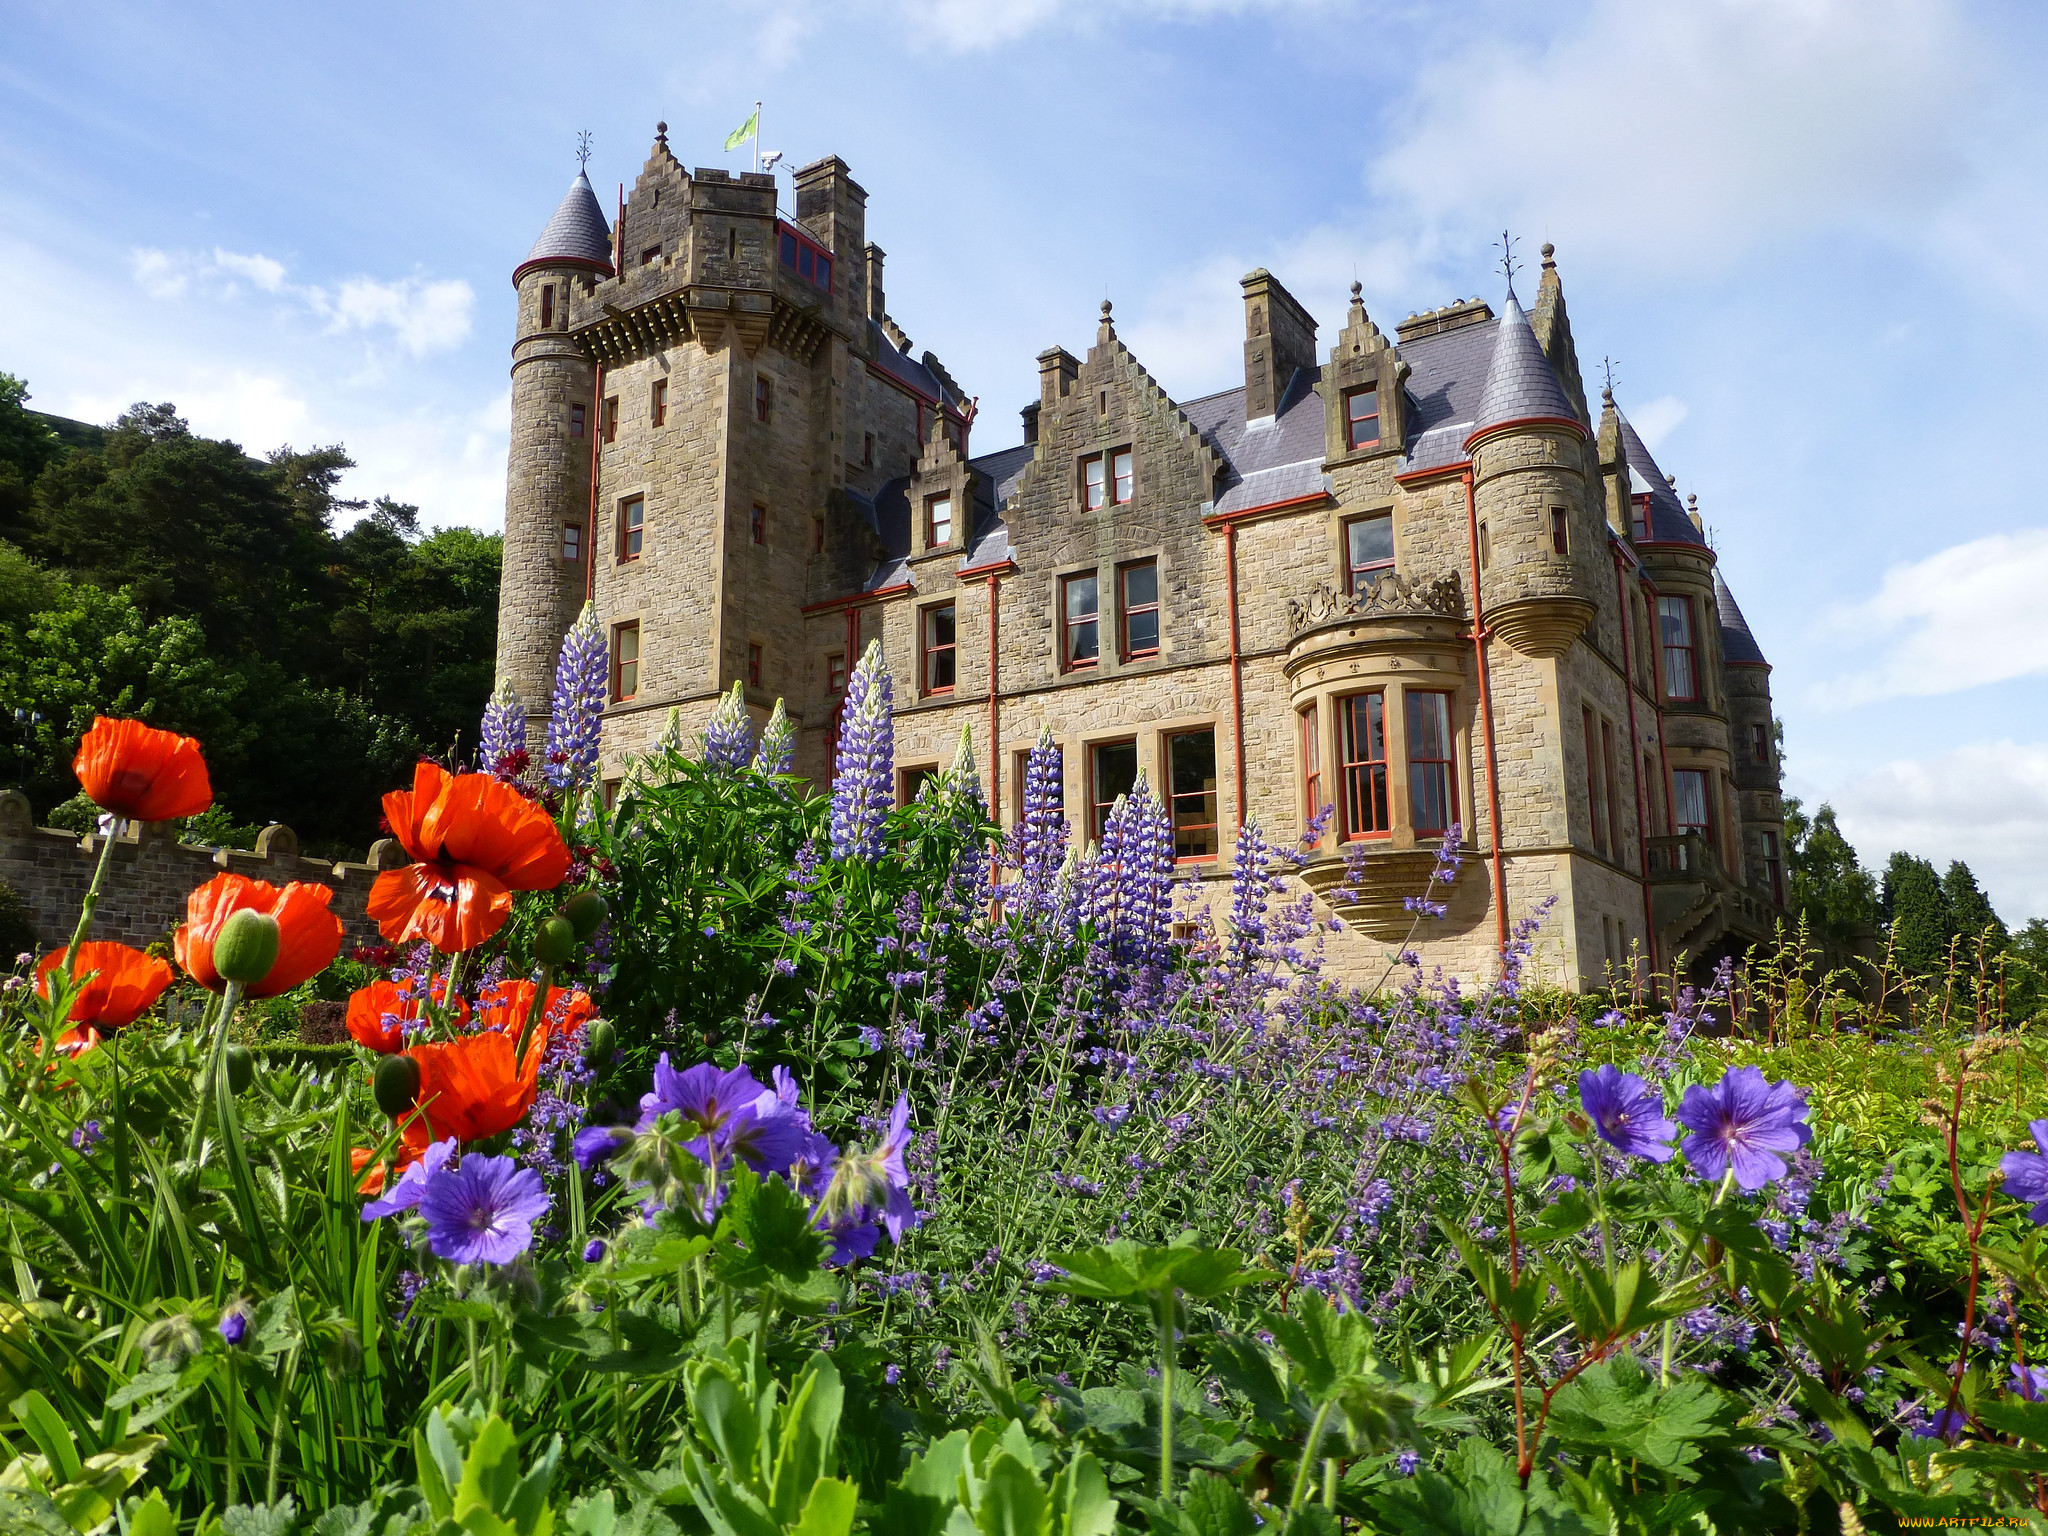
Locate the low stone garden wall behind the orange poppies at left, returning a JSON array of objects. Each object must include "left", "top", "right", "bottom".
[{"left": 0, "top": 791, "right": 395, "bottom": 963}]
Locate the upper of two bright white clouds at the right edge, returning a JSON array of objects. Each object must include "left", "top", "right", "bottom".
[{"left": 1815, "top": 528, "right": 2048, "bottom": 709}]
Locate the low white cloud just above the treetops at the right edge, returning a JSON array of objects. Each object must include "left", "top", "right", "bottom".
[{"left": 1829, "top": 741, "right": 2048, "bottom": 926}]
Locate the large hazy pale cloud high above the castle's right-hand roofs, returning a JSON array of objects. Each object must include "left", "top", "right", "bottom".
[{"left": 1370, "top": 0, "right": 1982, "bottom": 270}]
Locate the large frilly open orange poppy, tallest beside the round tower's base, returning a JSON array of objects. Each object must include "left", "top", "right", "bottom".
[{"left": 369, "top": 762, "right": 569, "bottom": 954}]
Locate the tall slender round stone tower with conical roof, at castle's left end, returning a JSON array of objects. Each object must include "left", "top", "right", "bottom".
[{"left": 498, "top": 172, "right": 612, "bottom": 715}]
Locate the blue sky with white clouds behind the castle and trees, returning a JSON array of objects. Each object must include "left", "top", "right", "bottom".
[{"left": 0, "top": 0, "right": 2048, "bottom": 922}]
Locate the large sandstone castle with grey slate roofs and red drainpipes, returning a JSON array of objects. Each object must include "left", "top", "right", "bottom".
[{"left": 498, "top": 127, "right": 1784, "bottom": 987}]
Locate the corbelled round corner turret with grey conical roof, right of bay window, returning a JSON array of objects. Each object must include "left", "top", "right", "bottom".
[{"left": 1464, "top": 289, "right": 1604, "bottom": 657}]
